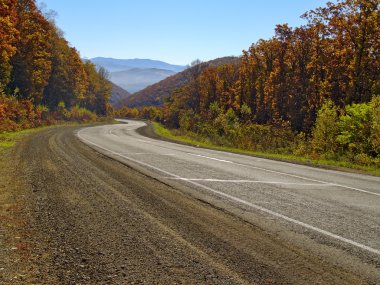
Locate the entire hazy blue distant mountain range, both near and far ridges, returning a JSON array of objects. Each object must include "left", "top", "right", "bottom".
[{"left": 90, "top": 57, "right": 186, "bottom": 93}]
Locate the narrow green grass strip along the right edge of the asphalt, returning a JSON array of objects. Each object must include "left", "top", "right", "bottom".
[{"left": 153, "top": 122, "right": 380, "bottom": 175}]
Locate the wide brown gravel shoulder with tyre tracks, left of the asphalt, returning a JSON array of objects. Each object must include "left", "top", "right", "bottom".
[{"left": 0, "top": 127, "right": 376, "bottom": 284}]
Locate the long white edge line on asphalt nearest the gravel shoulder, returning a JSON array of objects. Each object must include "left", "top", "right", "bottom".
[{"left": 77, "top": 130, "right": 380, "bottom": 255}]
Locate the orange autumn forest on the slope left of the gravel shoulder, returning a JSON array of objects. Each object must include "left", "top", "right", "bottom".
[{"left": 0, "top": 0, "right": 112, "bottom": 132}]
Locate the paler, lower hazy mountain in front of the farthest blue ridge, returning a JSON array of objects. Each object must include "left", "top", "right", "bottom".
[{"left": 110, "top": 68, "right": 176, "bottom": 93}]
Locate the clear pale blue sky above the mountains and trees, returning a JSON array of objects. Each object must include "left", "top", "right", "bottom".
[{"left": 38, "top": 0, "right": 327, "bottom": 65}]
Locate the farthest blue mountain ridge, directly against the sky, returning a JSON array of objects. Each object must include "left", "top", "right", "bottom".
[{"left": 90, "top": 57, "right": 186, "bottom": 72}]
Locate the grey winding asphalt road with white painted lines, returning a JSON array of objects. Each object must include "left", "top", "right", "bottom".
[{"left": 77, "top": 121, "right": 380, "bottom": 260}]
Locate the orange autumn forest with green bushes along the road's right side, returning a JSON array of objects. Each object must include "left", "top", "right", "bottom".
[{"left": 118, "top": 0, "right": 380, "bottom": 167}]
